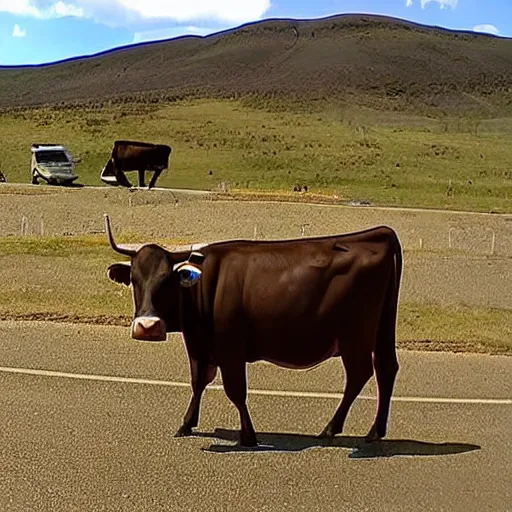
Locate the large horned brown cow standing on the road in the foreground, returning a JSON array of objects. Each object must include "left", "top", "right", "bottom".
[{"left": 105, "top": 215, "right": 402, "bottom": 446}]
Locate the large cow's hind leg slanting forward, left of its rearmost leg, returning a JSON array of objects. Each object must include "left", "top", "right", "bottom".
[{"left": 320, "top": 351, "right": 373, "bottom": 439}]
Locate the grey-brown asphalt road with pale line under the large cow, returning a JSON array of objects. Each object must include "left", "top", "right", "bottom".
[{"left": 0, "top": 322, "right": 512, "bottom": 512}]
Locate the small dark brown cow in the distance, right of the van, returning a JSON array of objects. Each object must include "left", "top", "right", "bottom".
[{"left": 101, "top": 140, "right": 172, "bottom": 190}]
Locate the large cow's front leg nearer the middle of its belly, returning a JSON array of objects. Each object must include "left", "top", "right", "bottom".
[{"left": 220, "top": 362, "right": 258, "bottom": 446}]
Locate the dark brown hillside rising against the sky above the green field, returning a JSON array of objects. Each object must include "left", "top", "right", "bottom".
[{"left": 0, "top": 15, "right": 512, "bottom": 115}]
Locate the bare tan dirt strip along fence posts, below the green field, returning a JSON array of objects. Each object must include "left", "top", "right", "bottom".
[{"left": 0, "top": 185, "right": 512, "bottom": 253}]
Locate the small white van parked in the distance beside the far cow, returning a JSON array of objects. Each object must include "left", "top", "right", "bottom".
[{"left": 31, "top": 144, "right": 79, "bottom": 185}]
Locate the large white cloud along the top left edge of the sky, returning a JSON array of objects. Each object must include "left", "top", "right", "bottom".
[{"left": 0, "top": 0, "right": 270, "bottom": 24}]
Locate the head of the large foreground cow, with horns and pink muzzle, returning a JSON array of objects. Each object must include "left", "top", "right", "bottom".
[{"left": 105, "top": 215, "right": 205, "bottom": 341}]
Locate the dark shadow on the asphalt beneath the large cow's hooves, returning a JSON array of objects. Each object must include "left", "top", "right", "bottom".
[{"left": 194, "top": 429, "right": 481, "bottom": 459}]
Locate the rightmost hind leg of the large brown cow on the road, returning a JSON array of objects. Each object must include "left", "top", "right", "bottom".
[{"left": 366, "top": 346, "right": 398, "bottom": 442}]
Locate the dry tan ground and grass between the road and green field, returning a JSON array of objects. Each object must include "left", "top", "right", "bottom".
[{"left": 0, "top": 189, "right": 512, "bottom": 353}]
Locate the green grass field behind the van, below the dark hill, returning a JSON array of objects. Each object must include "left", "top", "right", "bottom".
[{"left": 0, "top": 100, "right": 512, "bottom": 212}]
